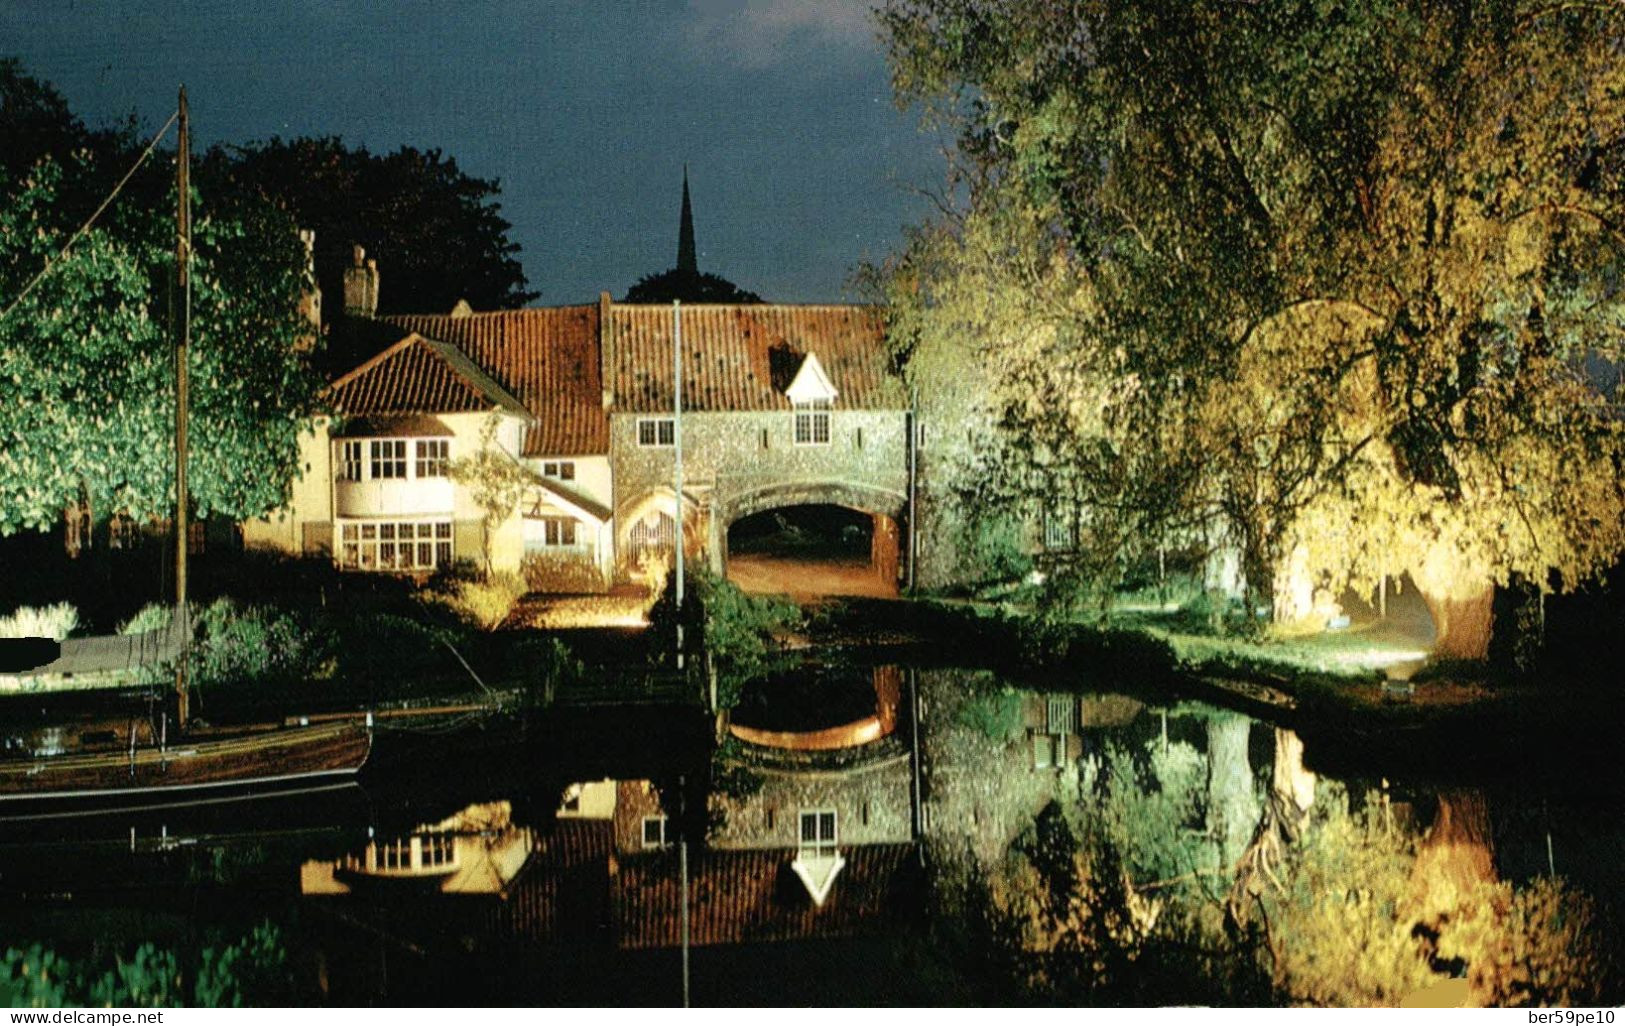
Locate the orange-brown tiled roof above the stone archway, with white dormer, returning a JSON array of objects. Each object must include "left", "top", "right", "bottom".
[{"left": 605, "top": 304, "right": 907, "bottom": 413}]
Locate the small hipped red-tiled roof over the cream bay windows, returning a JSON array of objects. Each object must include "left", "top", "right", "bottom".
[{"left": 328, "top": 333, "right": 528, "bottom": 416}]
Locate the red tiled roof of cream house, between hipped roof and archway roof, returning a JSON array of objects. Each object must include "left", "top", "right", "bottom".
[{"left": 380, "top": 304, "right": 609, "bottom": 457}]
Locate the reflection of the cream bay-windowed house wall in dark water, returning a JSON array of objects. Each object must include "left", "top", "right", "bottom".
[{"left": 299, "top": 802, "right": 531, "bottom": 894}]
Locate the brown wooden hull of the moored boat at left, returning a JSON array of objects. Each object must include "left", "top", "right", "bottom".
[{"left": 0, "top": 724, "right": 372, "bottom": 802}]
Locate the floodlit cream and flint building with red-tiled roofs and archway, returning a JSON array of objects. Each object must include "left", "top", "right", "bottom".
[{"left": 244, "top": 247, "right": 910, "bottom": 592}]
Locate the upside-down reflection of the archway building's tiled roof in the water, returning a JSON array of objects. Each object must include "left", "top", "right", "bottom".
[{"left": 613, "top": 844, "right": 918, "bottom": 948}]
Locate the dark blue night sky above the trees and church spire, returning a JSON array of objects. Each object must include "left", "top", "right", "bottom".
[{"left": 0, "top": 0, "right": 943, "bottom": 304}]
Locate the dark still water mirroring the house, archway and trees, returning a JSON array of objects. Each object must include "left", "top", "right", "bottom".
[{"left": 0, "top": 667, "right": 1622, "bottom": 1003}]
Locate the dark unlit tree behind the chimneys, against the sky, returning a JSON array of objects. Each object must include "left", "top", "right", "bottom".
[{"left": 198, "top": 137, "right": 538, "bottom": 319}]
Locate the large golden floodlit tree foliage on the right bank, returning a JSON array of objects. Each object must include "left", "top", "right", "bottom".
[{"left": 881, "top": 0, "right": 1625, "bottom": 655}]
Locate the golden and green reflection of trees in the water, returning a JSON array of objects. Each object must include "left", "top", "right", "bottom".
[{"left": 949, "top": 711, "right": 1610, "bottom": 1005}]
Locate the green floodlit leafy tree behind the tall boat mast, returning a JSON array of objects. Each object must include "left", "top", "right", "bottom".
[{"left": 0, "top": 94, "right": 320, "bottom": 533}]
